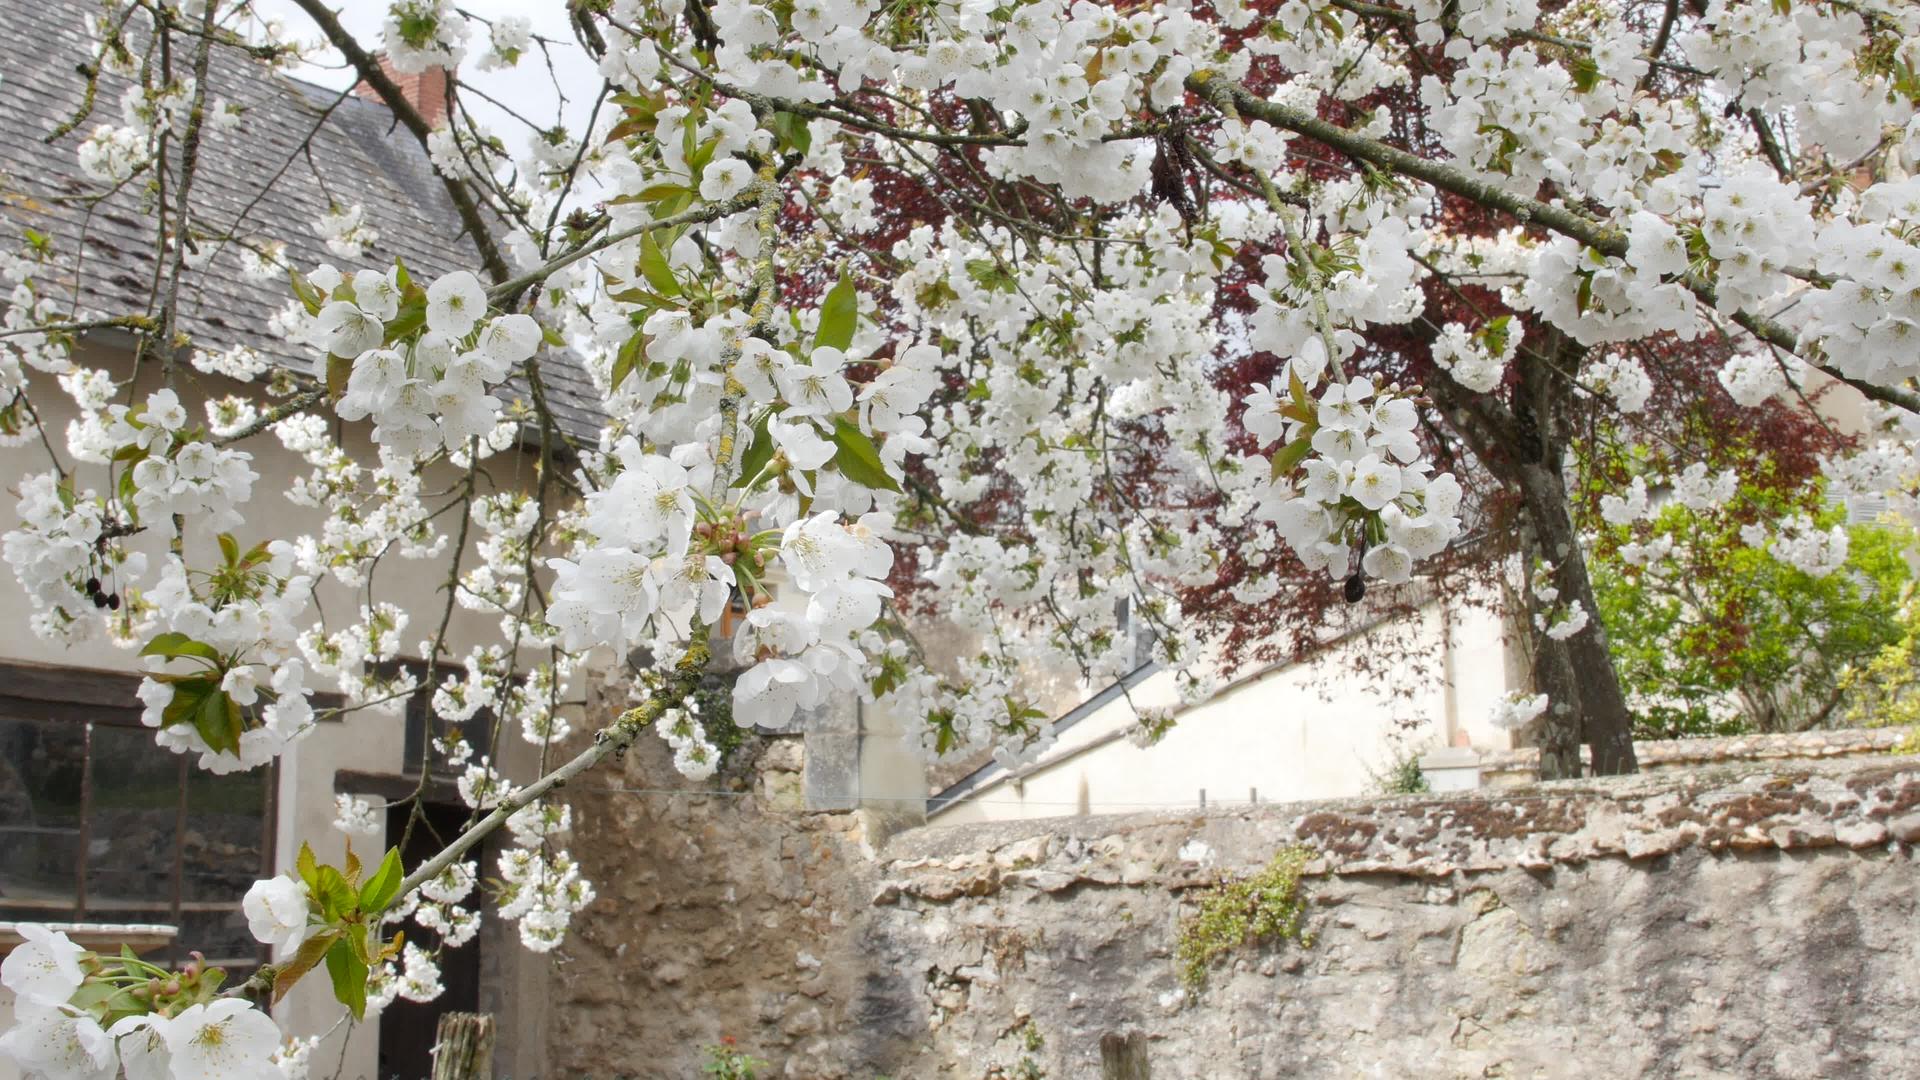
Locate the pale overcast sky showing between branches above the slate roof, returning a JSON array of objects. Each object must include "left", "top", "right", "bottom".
[{"left": 253, "top": 0, "right": 599, "bottom": 156}]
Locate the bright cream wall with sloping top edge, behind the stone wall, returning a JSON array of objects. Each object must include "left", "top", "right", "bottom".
[{"left": 931, "top": 591, "right": 1509, "bottom": 824}]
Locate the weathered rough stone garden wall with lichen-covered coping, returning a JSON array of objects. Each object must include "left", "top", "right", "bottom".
[{"left": 549, "top": 740, "right": 1920, "bottom": 1080}]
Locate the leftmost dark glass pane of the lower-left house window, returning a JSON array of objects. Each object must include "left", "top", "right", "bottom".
[{"left": 0, "top": 717, "right": 86, "bottom": 920}]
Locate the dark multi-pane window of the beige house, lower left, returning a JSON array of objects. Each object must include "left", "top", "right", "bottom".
[{"left": 0, "top": 663, "right": 275, "bottom": 970}]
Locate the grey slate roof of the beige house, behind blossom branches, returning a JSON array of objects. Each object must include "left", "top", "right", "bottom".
[{"left": 0, "top": 0, "right": 601, "bottom": 440}]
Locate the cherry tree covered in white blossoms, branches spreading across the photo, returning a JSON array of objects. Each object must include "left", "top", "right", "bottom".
[{"left": 0, "top": 0, "right": 1920, "bottom": 1076}]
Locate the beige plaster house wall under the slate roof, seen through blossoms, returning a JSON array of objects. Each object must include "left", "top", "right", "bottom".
[{"left": 0, "top": 348, "right": 568, "bottom": 1080}]
